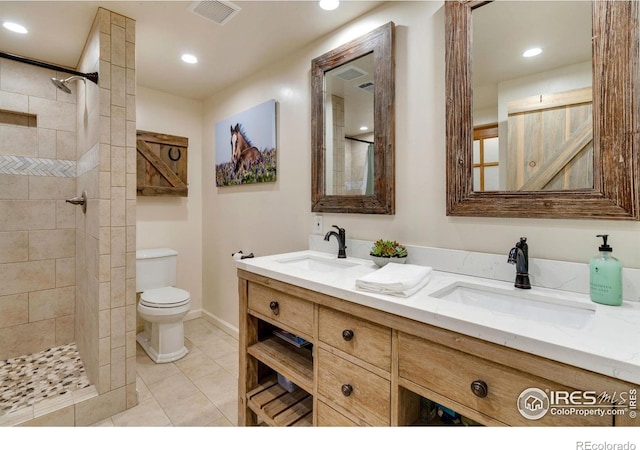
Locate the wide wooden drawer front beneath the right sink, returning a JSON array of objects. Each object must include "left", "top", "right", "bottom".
[{"left": 398, "top": 332, "right": 613, "bottom": 426}]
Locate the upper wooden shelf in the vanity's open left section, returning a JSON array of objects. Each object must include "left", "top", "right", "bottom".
[{"left": 247, "top": 337, "right": 313, "bottom": 392}]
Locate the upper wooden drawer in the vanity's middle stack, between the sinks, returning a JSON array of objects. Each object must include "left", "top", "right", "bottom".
[{"left": 318, "top": 307, "right": 391, "bottom": 372}]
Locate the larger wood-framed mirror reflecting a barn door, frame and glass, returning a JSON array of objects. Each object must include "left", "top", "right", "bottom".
[{"left": 445, "top": 0, "right": 640, "bottom": 220}]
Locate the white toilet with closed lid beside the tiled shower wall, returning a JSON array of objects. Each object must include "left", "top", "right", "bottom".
[{"left": 136, "top": 248, "right": 191, "bottom": 363}]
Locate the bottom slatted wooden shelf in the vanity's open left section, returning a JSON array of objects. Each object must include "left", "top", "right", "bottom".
[{"left": 247, "top": 375, "right": 313, "bottom": 427}]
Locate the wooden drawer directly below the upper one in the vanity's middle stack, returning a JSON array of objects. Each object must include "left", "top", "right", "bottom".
[{"left": 316, "top": 348, "right": 391, "bottom": 426}]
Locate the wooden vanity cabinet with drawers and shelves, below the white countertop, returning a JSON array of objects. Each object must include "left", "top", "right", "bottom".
[{"left": 238, "top": 269, "right": 640, "bottom": 426}]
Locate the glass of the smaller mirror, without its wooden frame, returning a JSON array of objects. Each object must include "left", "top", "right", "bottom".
[{"left": 324, "top": 53, "right": 375, "bottom": 195}]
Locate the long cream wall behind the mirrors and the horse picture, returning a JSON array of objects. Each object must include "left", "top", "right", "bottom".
[{"left": 202, "top": 1, "right": 640, "bottom": 326}]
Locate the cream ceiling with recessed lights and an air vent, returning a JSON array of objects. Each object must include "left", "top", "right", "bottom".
[{"left": 0, "top": 0, "right": 384, "bottom": 99}]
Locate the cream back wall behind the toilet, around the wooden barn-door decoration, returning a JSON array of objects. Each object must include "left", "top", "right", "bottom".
[{"left": 136, "top": 86, "right": 204, "bottom": 318}]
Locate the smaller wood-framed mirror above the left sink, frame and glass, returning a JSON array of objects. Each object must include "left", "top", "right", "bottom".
[{"left": 311, "top": 22, "right": 395, "bottom": 214}]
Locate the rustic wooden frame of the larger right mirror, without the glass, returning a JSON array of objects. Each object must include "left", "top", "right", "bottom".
[{"left": 445, "top": 0, "right": 640, "bottom": 220}]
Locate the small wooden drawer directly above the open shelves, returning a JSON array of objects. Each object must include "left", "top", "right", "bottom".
[{"left": 248, "top": 283, "right": 314, "bottom": 337}]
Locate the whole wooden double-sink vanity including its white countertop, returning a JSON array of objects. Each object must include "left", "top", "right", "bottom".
[{"left": 237, "top": 251, "right": 640, "bottom": 426}]
